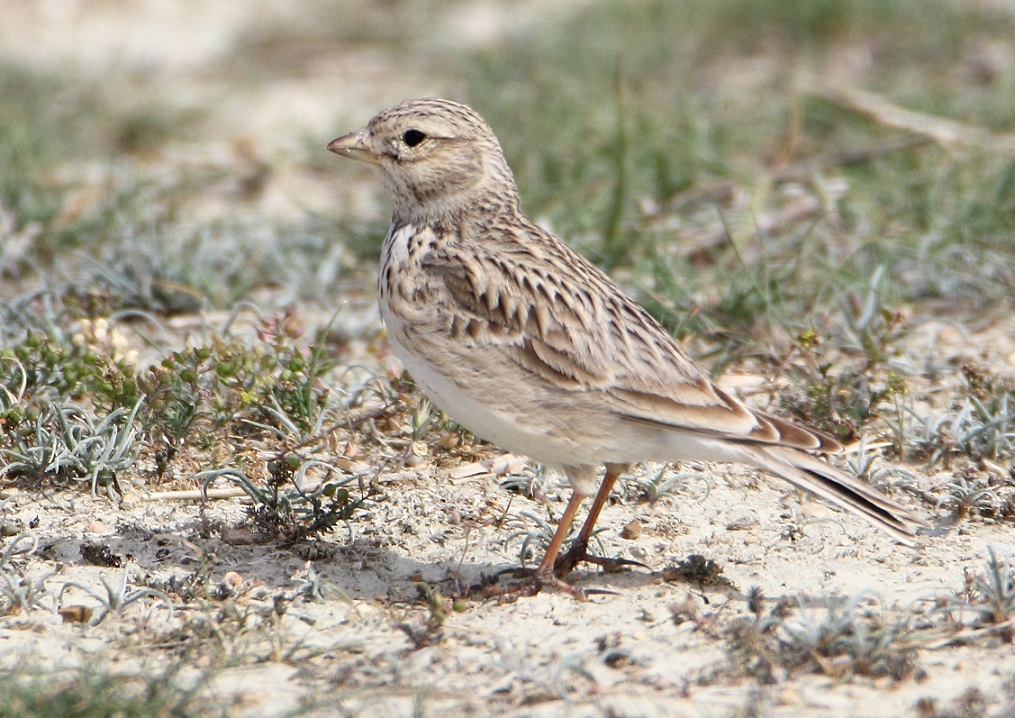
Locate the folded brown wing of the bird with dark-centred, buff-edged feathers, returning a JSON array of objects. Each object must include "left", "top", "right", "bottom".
[{"left": 421, "top": 224, "right": 841, "bottom": 451}]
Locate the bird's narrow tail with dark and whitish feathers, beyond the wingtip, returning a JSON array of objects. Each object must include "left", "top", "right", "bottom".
[{"left": 750, "top": 445, "right": 928, "bottom": 545}]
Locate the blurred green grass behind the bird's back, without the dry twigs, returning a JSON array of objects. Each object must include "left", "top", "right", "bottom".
[{"left": 466, "top": 0, "right": 1015, "bottom": 308}]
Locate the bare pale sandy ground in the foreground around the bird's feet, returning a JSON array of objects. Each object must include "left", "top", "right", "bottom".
[{"left": 0, "top": 424, "right": 1015, "bottom": 716}]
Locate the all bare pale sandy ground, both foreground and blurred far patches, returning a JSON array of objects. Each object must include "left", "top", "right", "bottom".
[{"left": 0, "top": 0, "right": 1015, "bottom": 716}]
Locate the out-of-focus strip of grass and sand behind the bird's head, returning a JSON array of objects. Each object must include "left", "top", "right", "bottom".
[{"left": 0, "top": 0, "right": 1015, "bottom": 318}]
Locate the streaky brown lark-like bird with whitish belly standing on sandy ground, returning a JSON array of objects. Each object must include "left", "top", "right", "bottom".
[{"left": 327, "top": 97, "right": 927, "bottom": 598}]
